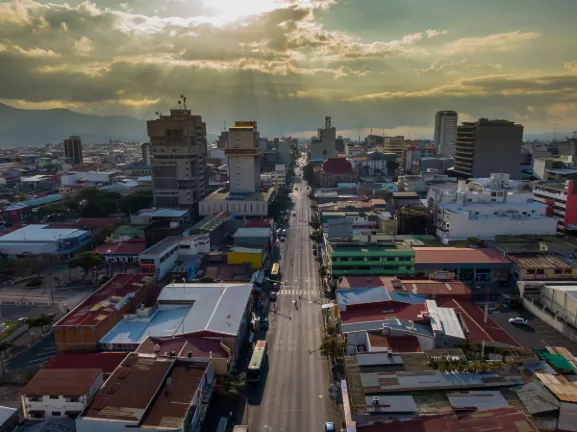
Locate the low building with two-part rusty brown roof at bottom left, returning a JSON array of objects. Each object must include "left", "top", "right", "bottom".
[{"left": 76, "top": 353, "right": 215, "bottom": 432}]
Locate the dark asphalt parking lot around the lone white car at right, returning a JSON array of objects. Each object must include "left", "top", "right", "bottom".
[{"left": 491, "top": 308, "right": 577, "bottom": 356}]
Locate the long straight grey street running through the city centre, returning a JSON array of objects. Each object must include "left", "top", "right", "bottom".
[{"left": 244, "top": 164, "right": 335, "bottom": 432}]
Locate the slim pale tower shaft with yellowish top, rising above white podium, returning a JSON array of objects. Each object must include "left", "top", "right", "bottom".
[{"left": 224, "top": 121, "right": 260, "bottom": 194}]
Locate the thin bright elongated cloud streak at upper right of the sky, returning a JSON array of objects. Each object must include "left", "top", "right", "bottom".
[{"left": 442, "top": 31, "right": 541, "bottom": 55}]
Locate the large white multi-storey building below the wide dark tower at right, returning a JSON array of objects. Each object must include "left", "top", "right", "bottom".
[{"left": 428, "top": 173, "right": 557, "bottom": 243}]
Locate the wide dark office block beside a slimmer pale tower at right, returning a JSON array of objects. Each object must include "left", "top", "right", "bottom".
[{"left": 455, "top": 118, "right": 523, "bottom": 180}]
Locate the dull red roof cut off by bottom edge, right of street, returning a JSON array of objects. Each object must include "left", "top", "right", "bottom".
[{"left": 357, "top": 407, "right": 539, "bottom": 432}]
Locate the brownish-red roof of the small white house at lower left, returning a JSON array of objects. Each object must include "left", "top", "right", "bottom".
[{"left": 20, "top": 368, "right": 102, "bottom": 396}]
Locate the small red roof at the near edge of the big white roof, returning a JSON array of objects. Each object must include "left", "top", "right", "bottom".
[{"left": 136, "top": 334, "right": 229, "bottom": 359}]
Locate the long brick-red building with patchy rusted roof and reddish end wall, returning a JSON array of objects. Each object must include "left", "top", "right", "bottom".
[{"left": 54, "top": 273, "right": 156, "bottom": 352}]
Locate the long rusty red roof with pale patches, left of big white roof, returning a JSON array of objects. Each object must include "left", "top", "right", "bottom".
[{"left": 54, "top": 273, "right": 154, "bottom": 326}]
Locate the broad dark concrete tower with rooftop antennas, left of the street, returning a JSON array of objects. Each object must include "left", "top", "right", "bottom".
[{"left": 147, "top": 96, "right": 207, "bottom": 220}]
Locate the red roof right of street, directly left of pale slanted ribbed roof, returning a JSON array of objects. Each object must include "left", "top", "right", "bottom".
[{"left": 341, "top": 301, "right": 427, "bottom": 324}]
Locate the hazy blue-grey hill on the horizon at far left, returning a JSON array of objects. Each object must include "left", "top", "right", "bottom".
[{"left": 0, "top": 103, "right": 216, "bottom": 147}]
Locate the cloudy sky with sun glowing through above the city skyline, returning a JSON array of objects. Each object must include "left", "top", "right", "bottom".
[{"left": 0, "top": 0, "right": 577, "bottom": 138}]
